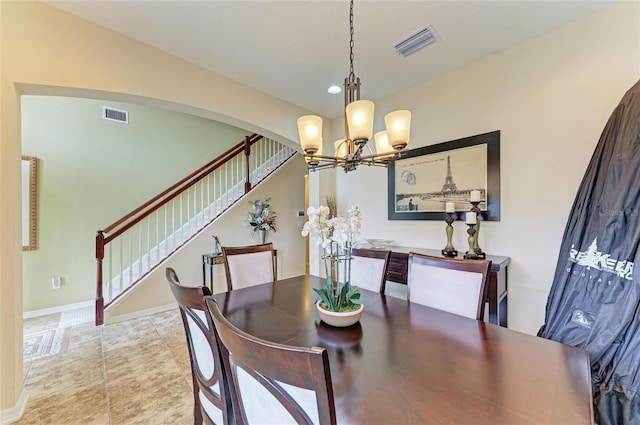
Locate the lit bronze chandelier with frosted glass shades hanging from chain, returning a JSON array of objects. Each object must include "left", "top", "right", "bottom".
[{"left": 298, "top": 0, "right": 411, "bottom": 173}]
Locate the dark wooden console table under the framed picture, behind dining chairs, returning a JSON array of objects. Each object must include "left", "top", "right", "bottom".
[{"left": 387, "top": 246, "right": 511, "bottom": 328}]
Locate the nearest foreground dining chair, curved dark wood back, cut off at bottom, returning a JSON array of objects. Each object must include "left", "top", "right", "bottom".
[{"left": 206, "top": 297, "right": 336, "bottom": 425}]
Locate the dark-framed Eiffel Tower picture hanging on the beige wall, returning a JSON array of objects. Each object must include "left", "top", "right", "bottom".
[{"left": 388, "top": 130, "right": 500, "bottom": 221}]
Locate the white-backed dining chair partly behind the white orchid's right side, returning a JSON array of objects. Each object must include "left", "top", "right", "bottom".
[{"left": 350, "top": 248, "right": 391, "bottom": 294}]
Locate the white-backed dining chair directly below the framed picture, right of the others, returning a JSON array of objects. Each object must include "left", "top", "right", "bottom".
[{"left": 407, "top": 252, "right": 491, "bottom": 320}]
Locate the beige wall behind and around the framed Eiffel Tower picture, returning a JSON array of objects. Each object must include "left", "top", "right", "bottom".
[{"left": 331, "top": 2, "right": 640, "bottom": 333}]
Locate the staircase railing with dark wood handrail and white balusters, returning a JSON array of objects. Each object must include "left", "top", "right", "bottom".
[{"left": 96, "top": 134, "right": 296, "bottom": 325}]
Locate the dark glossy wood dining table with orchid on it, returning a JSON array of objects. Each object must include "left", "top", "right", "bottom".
[{"left": 215, "top": 275, "right": 593, "bottom": 425}]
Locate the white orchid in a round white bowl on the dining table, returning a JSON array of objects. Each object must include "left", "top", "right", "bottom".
[{"left": 302, "top": 205, "right": 364, "bottom": 326}]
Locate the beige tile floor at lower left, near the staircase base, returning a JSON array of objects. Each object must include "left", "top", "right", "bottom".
[{"left": 16, "top": 308, "right": 193, "bottom": 425}]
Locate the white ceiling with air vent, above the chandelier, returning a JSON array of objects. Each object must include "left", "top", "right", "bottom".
[{"left": 47, "top": 0, "right": 610, "bottom": 117}]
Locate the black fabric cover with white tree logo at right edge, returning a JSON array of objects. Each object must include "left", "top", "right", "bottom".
[{"left": 539, "top": 81, "right": 640, "bottom": 425}]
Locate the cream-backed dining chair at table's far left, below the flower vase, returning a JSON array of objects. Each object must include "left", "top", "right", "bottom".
[{"left": 222, "top": 243, "right": 275, "bottom": 291}]
